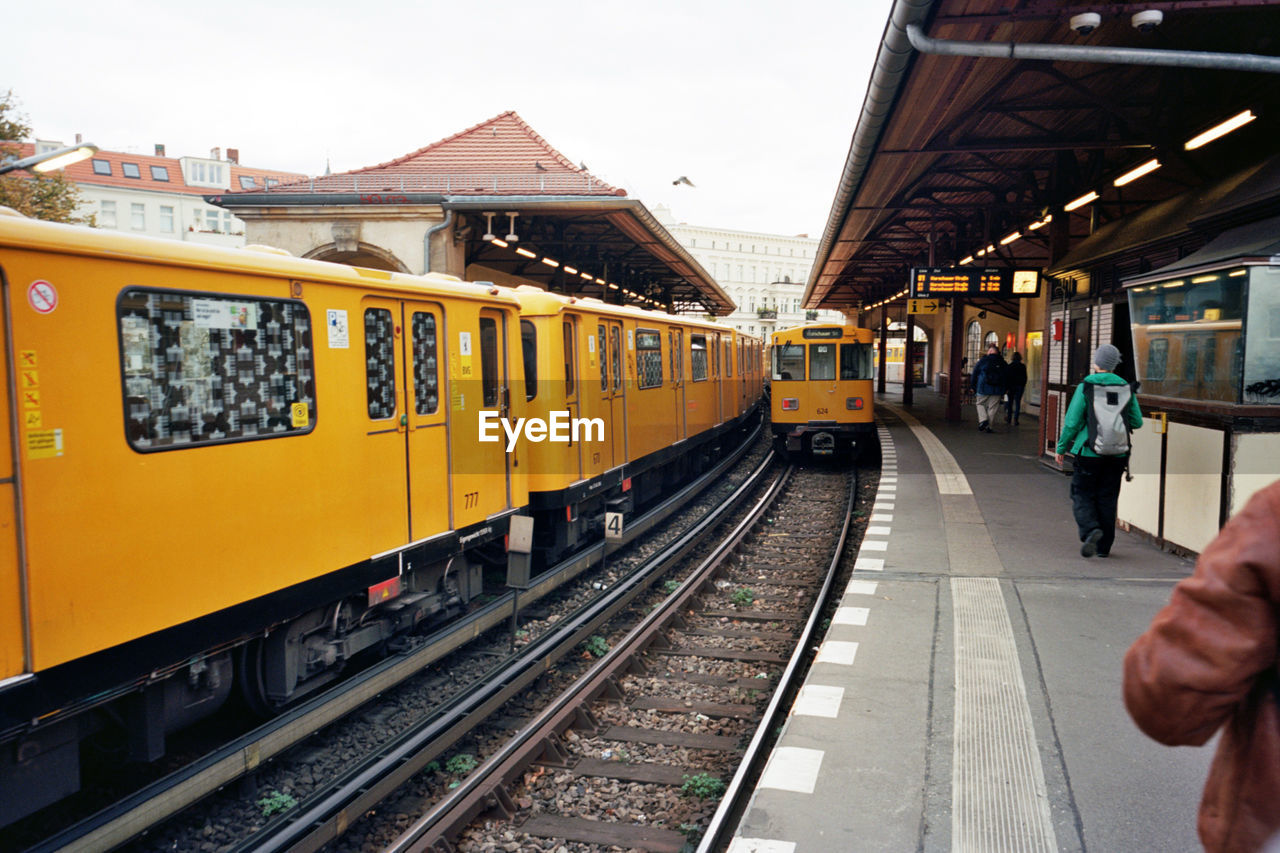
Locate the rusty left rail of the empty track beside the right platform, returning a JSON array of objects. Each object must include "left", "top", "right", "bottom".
[{"left": 384, "top": 458, "right": 795, "bottom": 853}]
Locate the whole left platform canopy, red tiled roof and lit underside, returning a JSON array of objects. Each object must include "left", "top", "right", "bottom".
[{"left": 215, "top": 111, "right": 733, "bottom": 315}]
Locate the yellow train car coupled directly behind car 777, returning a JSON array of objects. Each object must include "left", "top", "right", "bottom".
[{"left": 515, "top": 286, "right": 759, "bottom": 562}]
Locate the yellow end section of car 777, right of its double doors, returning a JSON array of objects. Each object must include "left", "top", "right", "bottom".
[{"left": 447, "top": 309, "right": 512, "bottom": 529}]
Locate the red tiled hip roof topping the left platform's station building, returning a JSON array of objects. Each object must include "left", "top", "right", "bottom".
[{"left": 239, "top": 111, "right": 626, "bottom": 196}]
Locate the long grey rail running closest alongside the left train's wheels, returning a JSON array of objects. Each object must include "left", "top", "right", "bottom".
[{"left": 35, "top": 424, "right": 763, "bottom": 853}]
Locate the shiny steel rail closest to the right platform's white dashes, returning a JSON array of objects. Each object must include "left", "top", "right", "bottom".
[{"left": 696, "top": 470, "right": 858, "bottom": 853}]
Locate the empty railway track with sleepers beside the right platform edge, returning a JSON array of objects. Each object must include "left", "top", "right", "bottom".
[{"left": 371, "top": 469, "right": 856, "bottom": 853}]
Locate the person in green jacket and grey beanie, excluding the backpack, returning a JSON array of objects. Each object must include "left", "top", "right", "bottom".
[{"left": 1053, "top": 343, "right": 1142, "bottom": 557}]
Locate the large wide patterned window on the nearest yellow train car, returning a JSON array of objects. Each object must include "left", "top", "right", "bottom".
[{"left": 116, "top": 289, "right": 316, "bottom": 451}]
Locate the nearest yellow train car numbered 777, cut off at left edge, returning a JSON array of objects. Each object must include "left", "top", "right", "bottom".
[{"left": 0, "top": 207, "right": 529, "bottom": 825}]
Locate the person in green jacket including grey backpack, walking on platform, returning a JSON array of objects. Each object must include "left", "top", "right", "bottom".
[{"left": 1053, "top": 343, "right": 1142, "bottom": 557}]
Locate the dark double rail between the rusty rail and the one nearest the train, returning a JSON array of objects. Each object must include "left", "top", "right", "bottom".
[{"left": 232, "top": 452, "right": 773, "bottom": 853}]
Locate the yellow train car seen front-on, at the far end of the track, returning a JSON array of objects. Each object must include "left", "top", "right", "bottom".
[{"left": 769, "top": 323, "right": 876, "bottom": 456}]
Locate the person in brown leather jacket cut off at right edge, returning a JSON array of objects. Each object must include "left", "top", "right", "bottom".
[{"left": 1124, "top": 482, "right": 1280, "bottom": 853}]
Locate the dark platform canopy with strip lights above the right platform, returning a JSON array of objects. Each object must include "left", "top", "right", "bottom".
[{"left": 804, "top": 0, "right": 1280, "bottom": 316}]
